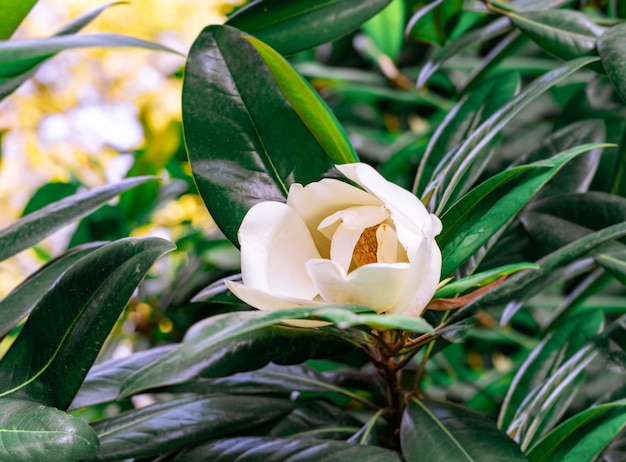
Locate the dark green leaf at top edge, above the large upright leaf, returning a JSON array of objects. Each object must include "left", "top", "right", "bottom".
[{"left": 226, "top": 0, "right": 391, "bottom": 55}]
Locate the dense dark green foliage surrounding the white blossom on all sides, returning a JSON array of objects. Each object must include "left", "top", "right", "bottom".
[{"left": 0, "top": 0, "right": 626, "bottom": 462}]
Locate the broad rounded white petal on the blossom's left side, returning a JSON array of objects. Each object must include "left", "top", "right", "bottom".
[{"left": 239, "top": 201, "right": 320, "bottom": 300}]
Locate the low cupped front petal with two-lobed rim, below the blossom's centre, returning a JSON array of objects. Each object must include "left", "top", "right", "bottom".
[{"left": 306, "top": 259, "right": 410, "bottom": 313}]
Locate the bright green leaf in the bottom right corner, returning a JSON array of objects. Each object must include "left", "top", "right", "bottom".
[{"left": 527, "top": 401, "right": 626, "bottom": 462}]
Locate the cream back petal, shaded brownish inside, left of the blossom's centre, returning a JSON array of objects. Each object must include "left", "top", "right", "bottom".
[{"left": 287, "top": 178, "right": 383, "bottom": 258}]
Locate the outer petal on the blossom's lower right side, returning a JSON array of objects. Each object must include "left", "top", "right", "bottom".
[{"left": 390, "top": 235, "right": 441, "bottom": 317}]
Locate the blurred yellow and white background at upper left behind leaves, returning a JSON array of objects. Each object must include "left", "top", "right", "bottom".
[{"left": 0, "top": 0, "right": 240, "bottom": 296}]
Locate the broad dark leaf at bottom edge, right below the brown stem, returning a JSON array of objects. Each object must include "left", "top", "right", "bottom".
[{"left": 400, "top": 398, "right": 527, "bottom": 462}]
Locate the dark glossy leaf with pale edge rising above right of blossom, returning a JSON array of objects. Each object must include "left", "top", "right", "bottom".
[{"left": 413, "top": 72, "right": 520, "bottom": 196}]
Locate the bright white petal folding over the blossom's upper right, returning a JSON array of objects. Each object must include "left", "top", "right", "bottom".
[{"left": 337, "top": 163, "right": 431, "bottom": 242}]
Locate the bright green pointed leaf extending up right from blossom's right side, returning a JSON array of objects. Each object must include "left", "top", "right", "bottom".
[{"left": 438, "top": 144, "right": 604, "bottom": 277}]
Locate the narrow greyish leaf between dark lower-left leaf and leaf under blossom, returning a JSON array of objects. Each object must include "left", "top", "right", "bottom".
[{"left": 69, "top": 344, "right": 178, "bottom": 410}]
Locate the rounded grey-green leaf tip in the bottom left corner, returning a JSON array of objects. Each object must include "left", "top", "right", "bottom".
[{"left": 0, "top": 398, "right": 99, "bottom": 462}]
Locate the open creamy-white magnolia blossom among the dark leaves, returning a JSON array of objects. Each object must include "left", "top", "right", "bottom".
[{"left": 227, "top": 163, "right": 441, "bottom": 322}]
